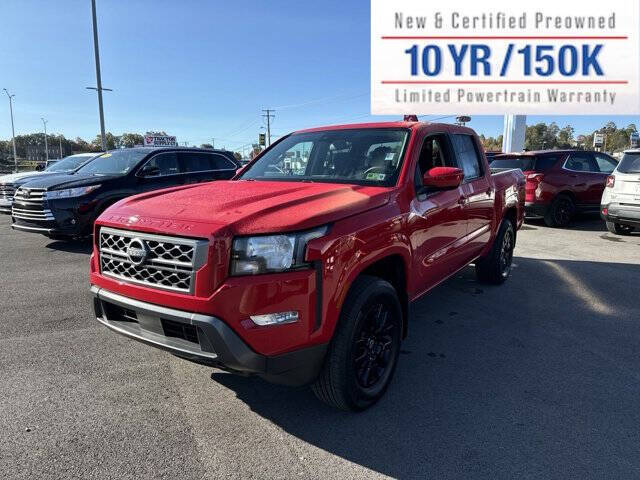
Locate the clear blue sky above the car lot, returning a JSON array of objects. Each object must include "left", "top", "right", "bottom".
[{"left": 0, "top": 0, "right": 640, "bottom": 149}]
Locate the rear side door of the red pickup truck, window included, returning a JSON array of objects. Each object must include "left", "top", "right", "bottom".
[{"left": 451, "top": 134, "right": 495, "bottom": 261}]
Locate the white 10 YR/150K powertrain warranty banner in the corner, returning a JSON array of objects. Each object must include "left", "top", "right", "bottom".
[{"left": 371, "top": 0, "right": 640, "bottom": 115}]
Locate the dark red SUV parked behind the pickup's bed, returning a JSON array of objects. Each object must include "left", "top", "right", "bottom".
[{"left": 491, "top": 150, "right": 618, "bottom": 227}]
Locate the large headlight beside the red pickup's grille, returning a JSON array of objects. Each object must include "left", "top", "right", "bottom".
[{"left": 231, "top": 226, "right": 328, "bottom": 276}]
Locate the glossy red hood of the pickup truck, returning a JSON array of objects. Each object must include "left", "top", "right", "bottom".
[{"left": 100, "top": 180, "right": 389, "bottom": 235}]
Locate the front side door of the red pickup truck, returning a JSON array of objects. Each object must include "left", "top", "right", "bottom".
[{"left": 407, "top": 133, "right": 467, "bottom": 294}]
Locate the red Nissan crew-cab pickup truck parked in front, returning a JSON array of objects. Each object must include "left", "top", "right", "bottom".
[{"left": 91, "top": 122, "right": 525, "bottom": 410}]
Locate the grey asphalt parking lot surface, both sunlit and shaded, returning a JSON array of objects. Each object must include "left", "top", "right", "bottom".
[{"left": 0, "top": 217, "right": 640, "bottom": 479}]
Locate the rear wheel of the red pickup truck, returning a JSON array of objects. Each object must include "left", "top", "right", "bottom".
[{"left": 476, "top": 218, "right": 516, "bottom": 285}]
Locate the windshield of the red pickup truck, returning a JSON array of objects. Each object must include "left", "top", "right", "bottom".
[{"left": 240, "top": 129, "right": 409, "bottom": 186}]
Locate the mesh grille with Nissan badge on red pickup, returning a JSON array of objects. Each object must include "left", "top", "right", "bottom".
[{"left": 99, "top": 227, "right": 208, "bottom": 294}]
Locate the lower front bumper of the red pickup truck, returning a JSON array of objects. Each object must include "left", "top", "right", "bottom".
[{"left": 91, "top": 285, "right": 327, "bottom": 385}]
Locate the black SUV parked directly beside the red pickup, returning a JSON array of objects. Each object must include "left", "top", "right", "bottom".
[{"left": 11, "top": 147, "right": 240, "bottom": 239}]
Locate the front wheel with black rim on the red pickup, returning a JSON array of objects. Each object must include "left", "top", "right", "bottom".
[{"left": 311, "top": 275, "right": 402, "bottom": 411}]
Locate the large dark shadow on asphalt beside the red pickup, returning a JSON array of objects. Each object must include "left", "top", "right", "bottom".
[{"left": 212, "top": 258, "right": 640, "bottom": 479}]
